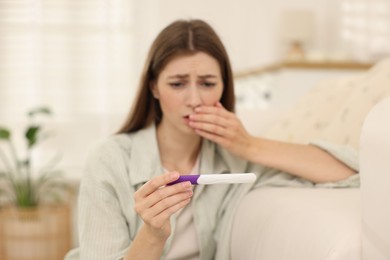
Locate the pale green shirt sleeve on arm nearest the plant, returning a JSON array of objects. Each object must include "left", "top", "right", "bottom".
[{"left": 78, "top": 141, "right": 134, "bottom": 260}]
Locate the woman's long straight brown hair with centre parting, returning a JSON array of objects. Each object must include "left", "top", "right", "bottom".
[{"left": 118, "top": 20, "right": 235, "bottom": 133}]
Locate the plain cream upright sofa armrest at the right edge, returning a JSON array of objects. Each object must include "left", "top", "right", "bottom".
[{"left": 360, "top": 96, "right": 390, "bottom": 260}]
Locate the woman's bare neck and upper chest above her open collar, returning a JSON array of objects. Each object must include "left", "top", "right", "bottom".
[{"left": 157, "top": 125, "right": 202, "bottom": 174}]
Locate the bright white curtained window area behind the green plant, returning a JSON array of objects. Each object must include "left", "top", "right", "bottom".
[{"left": 0, "top": 0, "right": 136, "bottom": 178}]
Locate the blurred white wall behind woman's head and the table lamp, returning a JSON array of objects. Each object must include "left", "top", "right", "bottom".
[{"left": 134, "top": 0, "right": 339, "bottom": 74}]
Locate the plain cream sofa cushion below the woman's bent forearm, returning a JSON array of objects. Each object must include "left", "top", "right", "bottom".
[{"left": 231, "top": 187, "right": 361, "bottom": 260}]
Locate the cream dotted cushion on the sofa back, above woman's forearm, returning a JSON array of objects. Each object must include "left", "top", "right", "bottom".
[{"left": 264, "top": 58, "right": 390, "bottom": 149}]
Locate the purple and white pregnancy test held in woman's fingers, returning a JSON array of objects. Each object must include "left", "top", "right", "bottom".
[{"left": 168, "top": 173, "right": 256, "bottom": 185}]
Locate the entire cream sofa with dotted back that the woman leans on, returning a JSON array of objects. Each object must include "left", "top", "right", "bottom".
[{"left": 231, "top": 59, "right": 390, "bottom": 260}]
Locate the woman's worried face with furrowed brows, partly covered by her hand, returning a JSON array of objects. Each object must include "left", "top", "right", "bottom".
[{"left": 152, "top": 52, "right": 224, "bottom": 134}]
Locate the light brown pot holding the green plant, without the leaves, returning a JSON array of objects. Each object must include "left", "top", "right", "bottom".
[{"left": 0, "top": 205, "right": 71, "bottom": 260}]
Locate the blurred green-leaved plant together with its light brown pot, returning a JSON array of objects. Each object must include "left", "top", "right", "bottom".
[{"left": 0, "top": 107, "right": 70, "bottom": 260}]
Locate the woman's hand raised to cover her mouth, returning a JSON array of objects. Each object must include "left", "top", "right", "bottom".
[{"left": 189, "top": 103, "right": 253, "bottom": 159}]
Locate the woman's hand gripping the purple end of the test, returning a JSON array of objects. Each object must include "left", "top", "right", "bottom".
[{"left": 134, "top": 172, "right": 193, "bottom": 240}]
